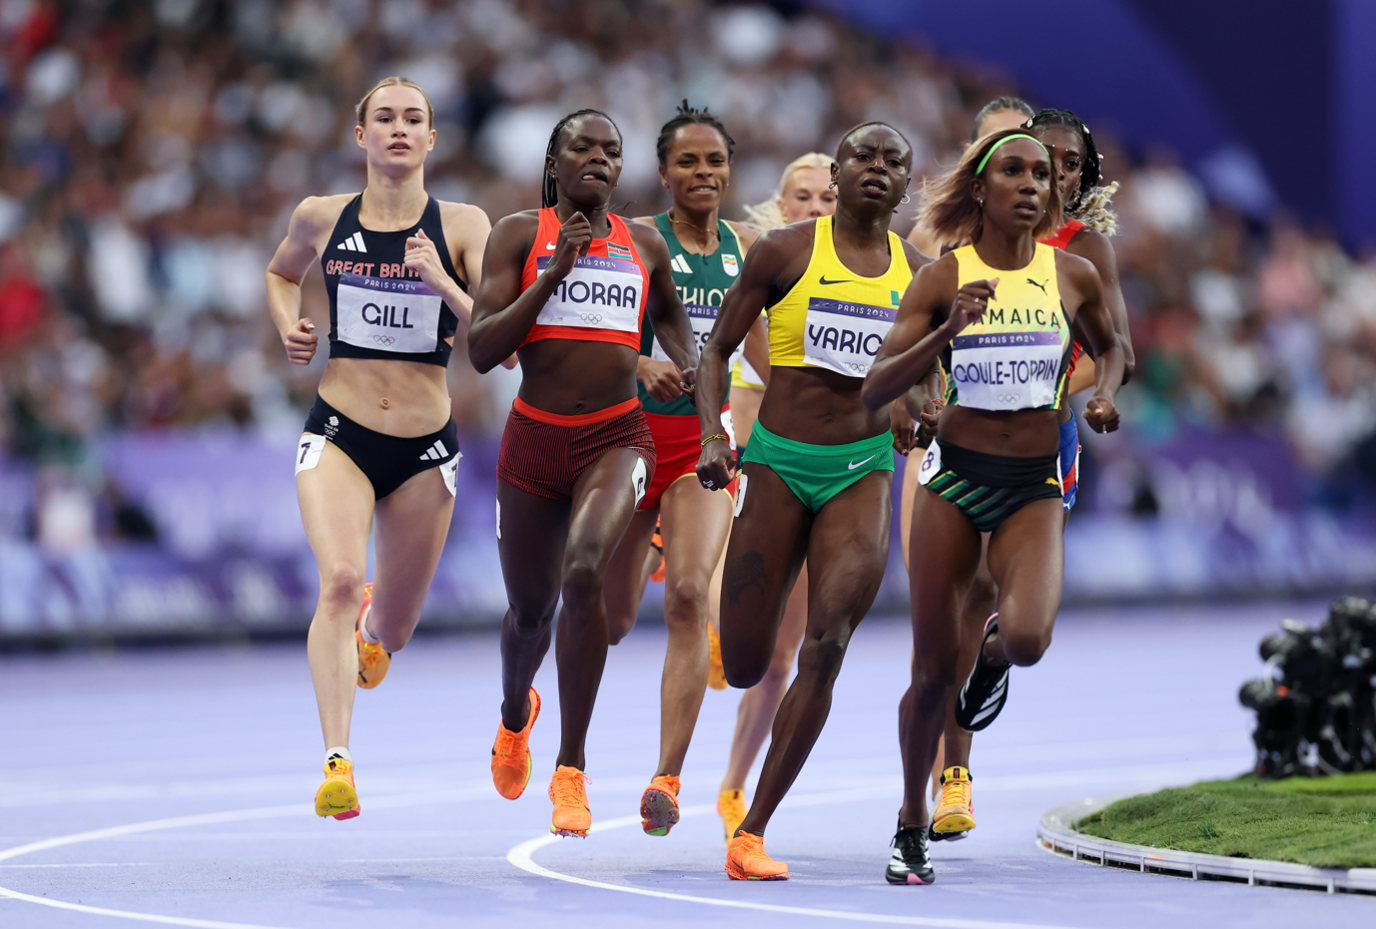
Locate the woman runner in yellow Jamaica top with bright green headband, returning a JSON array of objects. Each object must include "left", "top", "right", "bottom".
[{"left": 863, "top": 129, "right": 1123, "bottom": 884}]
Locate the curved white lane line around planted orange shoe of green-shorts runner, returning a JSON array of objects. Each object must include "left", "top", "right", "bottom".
[{"left": 506, "top": 787, "right": 1095, "bottom": 929}]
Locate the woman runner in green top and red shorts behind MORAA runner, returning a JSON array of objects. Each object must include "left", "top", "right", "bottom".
[{"left": 607, "top": 100, "right": 760, "bottom": 835}]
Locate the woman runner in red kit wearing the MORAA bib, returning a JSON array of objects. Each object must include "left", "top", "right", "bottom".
[{"left": 468, "top": 110, "right": 698, "bottom": 835}]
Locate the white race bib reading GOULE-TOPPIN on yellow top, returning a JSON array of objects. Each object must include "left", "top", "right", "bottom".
[{"left": 951, "top": 330, "right": 1065, "bottom": 410}]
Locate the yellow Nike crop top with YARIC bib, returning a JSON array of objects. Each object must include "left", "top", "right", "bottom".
[{"left": 765, "top": 216, "right": 912, "bottom": 377}]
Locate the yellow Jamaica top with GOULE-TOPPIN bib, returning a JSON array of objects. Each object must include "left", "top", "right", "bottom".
[{"left": 941, "top": 242, "right": 1075, "bottom": 410}]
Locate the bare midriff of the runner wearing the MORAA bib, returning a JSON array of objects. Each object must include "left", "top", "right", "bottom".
[{"left": 517, "top": 339, "right": 640, "bottom": 416}]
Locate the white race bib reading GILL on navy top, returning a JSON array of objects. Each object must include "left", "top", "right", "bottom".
[{"left": 336, "top": 274, "right": 444, "bottom": 352}]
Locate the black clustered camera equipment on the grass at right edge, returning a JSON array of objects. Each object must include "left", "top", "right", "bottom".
[{"left": 1237, "top": 597, "right": 1376, "bottom": 778}]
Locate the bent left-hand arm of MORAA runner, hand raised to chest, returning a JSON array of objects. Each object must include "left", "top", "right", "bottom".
[{"left": 468, "top": 213, "right": 593, "bottom": 374}]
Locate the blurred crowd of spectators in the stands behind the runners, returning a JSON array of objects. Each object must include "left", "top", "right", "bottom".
[{"left": 0, "top": 0, "right": 1376, "bottom": 522}]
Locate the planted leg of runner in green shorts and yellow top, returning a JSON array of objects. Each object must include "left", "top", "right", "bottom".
[{"left": 740, "top": 471, "right": 893, "bottom": 835}]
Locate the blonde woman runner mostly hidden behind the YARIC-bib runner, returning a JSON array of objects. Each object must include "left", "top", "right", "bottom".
[{"left": 707, "top": 151, "right": 837, "bottom": 841}]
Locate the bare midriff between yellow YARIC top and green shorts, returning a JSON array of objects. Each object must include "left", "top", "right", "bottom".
[{"left": 758, "top": 365, "right": 889, "bottom": 445}]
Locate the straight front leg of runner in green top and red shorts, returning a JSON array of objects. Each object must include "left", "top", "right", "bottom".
[{"left": 655, "top": 476, "right": 735, "bottom": 776}]
